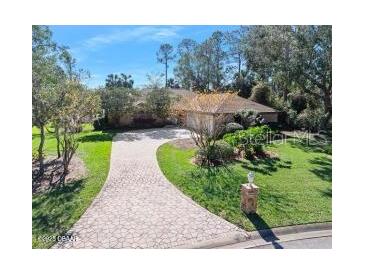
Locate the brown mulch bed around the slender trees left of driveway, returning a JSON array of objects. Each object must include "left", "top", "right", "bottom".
[{"left": 32, "top": 156, "right": 87, "bottom": 194}]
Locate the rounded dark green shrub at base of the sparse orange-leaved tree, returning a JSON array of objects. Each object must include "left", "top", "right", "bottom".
[{"left": 196, "top": 140, "right": 234, "bottom": 165}]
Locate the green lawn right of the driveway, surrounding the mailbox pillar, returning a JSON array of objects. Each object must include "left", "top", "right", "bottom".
[{"left": 157, "top": 140, "right": 332, "bottom": 230}]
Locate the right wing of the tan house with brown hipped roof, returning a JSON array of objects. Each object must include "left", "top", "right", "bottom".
[{"left": 172, "top": 93, "right": 279, "bottom": 131}]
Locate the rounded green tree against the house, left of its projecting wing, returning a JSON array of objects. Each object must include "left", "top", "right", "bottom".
[{"left": 146, "top": 89, "right": 171, "bottom": 119}]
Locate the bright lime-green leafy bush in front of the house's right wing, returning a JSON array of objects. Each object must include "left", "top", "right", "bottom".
[{"left": 223, "top": 125, "right": 270, "bottom": 158}]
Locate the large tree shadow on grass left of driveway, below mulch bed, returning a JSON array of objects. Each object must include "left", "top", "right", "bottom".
[{"left": 32, "top": 180, "right": 84, "bottom": 239}]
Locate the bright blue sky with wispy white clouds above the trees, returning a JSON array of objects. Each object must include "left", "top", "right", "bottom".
[{"left": 50, "top": 25, "right": 237, "bottom": 87}]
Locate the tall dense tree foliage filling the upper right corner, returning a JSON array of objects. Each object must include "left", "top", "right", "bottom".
[{"left": 245, "top": 25, "right": 332, "bottom": 123}]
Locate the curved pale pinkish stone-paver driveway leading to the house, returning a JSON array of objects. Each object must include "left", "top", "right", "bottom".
[{"left": 54, "top": 128, "right": 244, "bottom": 248}]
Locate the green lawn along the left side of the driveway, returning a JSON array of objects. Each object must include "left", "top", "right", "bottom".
[{"left": 32, "top": 125, "right": 113, "bottom": 248}]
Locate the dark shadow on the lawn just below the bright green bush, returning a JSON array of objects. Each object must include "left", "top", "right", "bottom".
[{"left": 242, "top": 158, "right": 292, "bottom": 175}]
